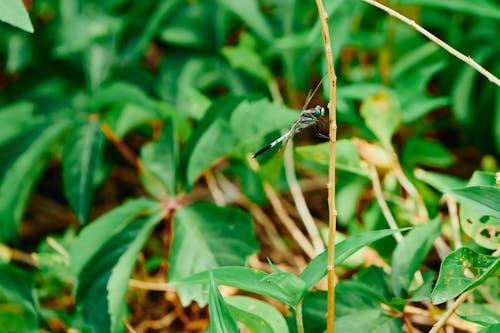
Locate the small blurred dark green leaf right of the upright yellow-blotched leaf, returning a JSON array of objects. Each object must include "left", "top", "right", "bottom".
[{"left": 401, "top": 137, "right": 455, "bottom": 168}]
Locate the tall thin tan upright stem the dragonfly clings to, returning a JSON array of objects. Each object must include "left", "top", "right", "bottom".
[{"left": 316, "top": 0, "right": 337, "bottom": 333}]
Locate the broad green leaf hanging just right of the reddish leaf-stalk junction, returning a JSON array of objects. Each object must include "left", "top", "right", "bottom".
[{"left": 169, "top": 202, "right": 259, "bottom": 306}]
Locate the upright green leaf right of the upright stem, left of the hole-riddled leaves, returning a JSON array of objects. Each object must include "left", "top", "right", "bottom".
[{"left": 391, "top": 218, "right": 441, "bottom": 297}]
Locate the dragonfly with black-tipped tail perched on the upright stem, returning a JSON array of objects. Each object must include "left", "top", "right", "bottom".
[{"left": 252, "top": 80, "right": 327, "bottom": 158}]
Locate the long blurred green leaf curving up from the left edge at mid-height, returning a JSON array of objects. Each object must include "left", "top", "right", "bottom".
[{"left": 0, "top": 121, "right": 68, "bottom": 241}]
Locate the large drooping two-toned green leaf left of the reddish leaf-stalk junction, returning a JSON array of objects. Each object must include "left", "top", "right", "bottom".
[{"left": 70, "top": 199, "right": 163, "bottom": 332}]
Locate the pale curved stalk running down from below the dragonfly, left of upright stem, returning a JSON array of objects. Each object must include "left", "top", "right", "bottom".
[{"left": 285, "top": 142, "right": 325, "bottom": 254}]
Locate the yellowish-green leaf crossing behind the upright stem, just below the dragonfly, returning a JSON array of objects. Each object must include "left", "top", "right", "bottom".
[{"left": 295, "top": 139, "right": 368, "bottom": 177}]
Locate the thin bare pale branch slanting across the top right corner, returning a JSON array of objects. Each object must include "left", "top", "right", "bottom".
[{"left": 364, "top": 0, "right": 500, "bottom": 86}]
